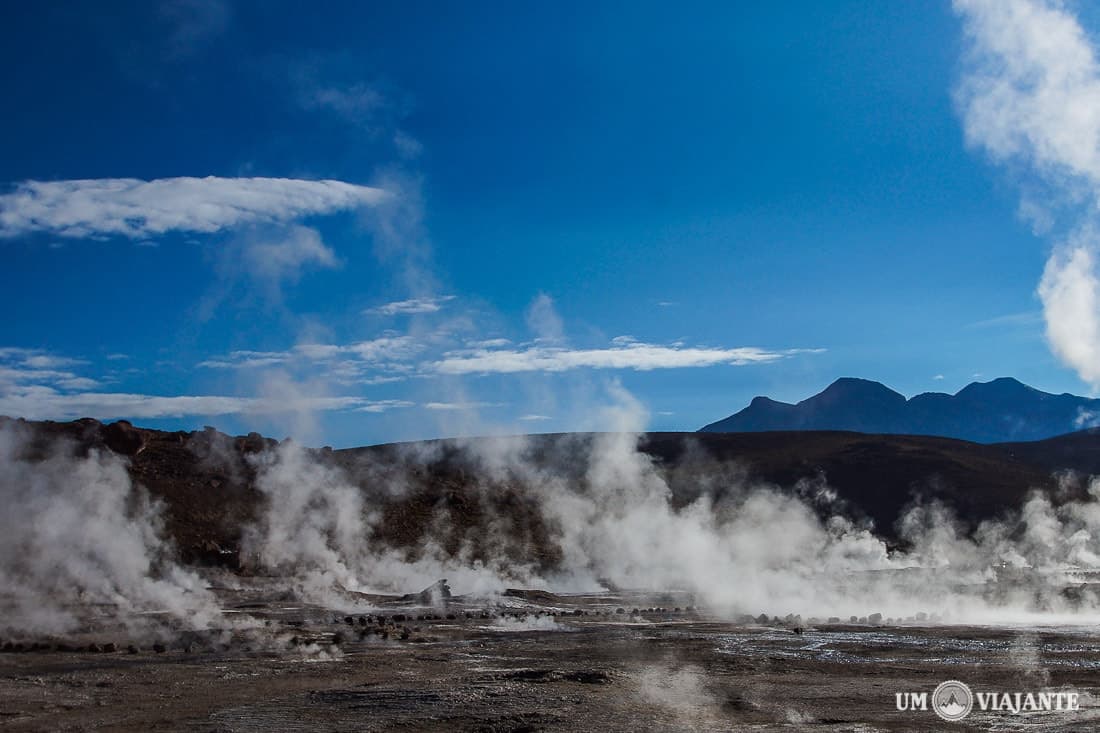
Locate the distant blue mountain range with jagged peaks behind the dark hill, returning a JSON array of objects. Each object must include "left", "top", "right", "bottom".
[{"left": 700, "top": 376, "right": 1100, "bottom": 442}]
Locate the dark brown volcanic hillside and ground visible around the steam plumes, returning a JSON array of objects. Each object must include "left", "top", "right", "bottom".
[{"left": 0, "top": 419, "right": 1100, "bottom": 732}]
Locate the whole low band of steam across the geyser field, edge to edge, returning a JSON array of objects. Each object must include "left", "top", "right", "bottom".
[{"left": 10, "top": 391, "right": 1100, "bottom": 651}]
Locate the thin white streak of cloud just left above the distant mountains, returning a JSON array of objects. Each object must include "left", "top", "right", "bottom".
[{"left": 428, "top": 341, "right": 821, "bottom": 374}]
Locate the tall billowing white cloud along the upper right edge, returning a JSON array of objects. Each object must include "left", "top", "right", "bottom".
[{"left": 955, "top": 0, "right": 1100, "bottom": 386}]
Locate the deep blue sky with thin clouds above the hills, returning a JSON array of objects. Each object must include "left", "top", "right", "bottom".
[{"left": 0, "top": 0, "right": 1100, "bottom": 446}]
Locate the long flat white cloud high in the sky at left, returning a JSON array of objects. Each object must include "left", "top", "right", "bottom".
[{"left": 0, "top": 176, "right": 387, "bottom": 239}]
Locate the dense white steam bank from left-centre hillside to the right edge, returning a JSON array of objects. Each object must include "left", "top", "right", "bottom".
[{"left": 225, "top": 378, "right": 1100, "bottom": 623}]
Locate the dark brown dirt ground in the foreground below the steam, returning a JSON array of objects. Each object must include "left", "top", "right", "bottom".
[{"left": 0, "top": 594, "right": 1100, "bottom": 733}]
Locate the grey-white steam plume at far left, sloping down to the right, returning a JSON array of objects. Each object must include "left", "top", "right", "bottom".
[{"left": 0, "top": 425, "right": 221, "bottom": 634}]
